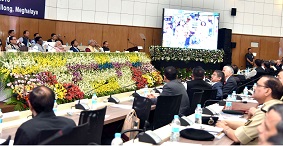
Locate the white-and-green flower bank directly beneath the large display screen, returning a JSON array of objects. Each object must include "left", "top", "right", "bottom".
[{"left": 149, "top": 46, "right": 224, "bottom": 64}]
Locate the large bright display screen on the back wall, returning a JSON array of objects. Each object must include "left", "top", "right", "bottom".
[{"left": 162, "top": 9, "right": 219, "bottom": 50}]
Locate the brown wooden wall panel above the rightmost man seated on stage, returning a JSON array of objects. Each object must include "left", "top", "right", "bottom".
[{"left": 101, "top": 25, "right": 128, "bottom": 52}]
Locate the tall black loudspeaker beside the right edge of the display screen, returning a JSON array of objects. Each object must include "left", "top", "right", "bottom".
[{"left": 217, "top": 28, "right": 232, "bottom": 53}]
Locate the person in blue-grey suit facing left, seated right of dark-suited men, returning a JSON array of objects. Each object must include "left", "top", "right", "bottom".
[{"left": 211, "top": 70, "right": 225, "bottom": 100}]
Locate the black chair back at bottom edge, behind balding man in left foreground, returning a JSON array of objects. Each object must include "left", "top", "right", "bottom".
[{"left": 40, "top": 123, "right": 89, "bottom": 145}]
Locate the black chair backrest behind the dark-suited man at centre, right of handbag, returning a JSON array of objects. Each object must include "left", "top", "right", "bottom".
[{"left": 152, "top": 94, "right": 182, "bottom": 130}]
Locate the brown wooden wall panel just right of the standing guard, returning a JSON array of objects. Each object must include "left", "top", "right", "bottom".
[{"left": 259, "top": 37, "right": 280, "bottom": 60}]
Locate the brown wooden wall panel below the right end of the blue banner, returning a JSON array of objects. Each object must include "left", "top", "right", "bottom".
[{"left": 38, "top": 20, "right": 56, "bottom": 40}]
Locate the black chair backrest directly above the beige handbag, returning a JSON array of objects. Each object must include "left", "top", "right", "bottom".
[{"left": 133, "top": 96, "right": 152, "bottom": 128}]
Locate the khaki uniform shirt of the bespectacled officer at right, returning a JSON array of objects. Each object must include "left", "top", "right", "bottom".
[{"left": 235, "top": 99, "right": 282, "bottom": 145}]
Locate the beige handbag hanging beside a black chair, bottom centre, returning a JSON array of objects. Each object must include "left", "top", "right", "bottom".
[{"left": 122, "top": 109, "right": 140, "bottom": 140}]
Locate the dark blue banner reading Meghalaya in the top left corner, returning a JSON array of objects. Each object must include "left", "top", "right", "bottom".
[{"left": 0, "top": 0, "right": 45, "bottom": 19}]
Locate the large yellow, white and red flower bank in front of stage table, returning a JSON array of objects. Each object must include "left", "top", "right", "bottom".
[{"left": 0, "top": 52, "right": 163, "bottom": 110}]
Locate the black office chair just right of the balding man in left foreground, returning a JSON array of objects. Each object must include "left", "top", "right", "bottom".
[{"left": 79, "top": 107, "right": 107, "bottom": 144}]
